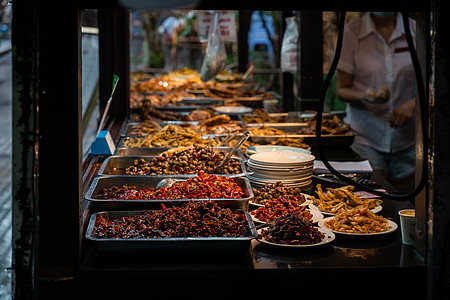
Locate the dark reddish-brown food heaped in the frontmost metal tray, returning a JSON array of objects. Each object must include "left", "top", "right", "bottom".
[{"left": 92, "top": 200, "right": 250, "bottom": 239}]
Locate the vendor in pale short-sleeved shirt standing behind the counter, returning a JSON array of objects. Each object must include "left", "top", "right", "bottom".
[{"left": 337, "top": 12, "right": 415, "bottom": 192}]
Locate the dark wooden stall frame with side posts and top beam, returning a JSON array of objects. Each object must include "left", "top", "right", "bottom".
[{"left": 12, "top": 0, "right": 450, "bottom": 299}]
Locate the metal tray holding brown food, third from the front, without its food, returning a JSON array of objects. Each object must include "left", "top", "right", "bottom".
[{"left": 98, "top": 155, "right": 247, "bottom": 178}]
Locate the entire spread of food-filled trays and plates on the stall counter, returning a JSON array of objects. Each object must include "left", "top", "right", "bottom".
[{"left": 86, "top": 69, "right": 396, "bottom": 260}]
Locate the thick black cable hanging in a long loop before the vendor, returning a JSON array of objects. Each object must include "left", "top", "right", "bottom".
[{"left": 316, "top": 11, "right": 428, "bottom": 200}]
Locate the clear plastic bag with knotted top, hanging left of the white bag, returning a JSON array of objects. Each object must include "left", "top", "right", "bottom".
[{"left": 200, "top": 12, "right": 227, "bottom": 82}]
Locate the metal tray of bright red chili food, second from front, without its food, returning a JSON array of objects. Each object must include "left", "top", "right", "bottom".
[{"left": 85, "top": 175, "right": 254, "bottom": 211}]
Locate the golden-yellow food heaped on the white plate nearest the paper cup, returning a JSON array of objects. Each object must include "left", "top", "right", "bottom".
[{"left": 325, "top": 205, "right": 391, "bottom": 234}]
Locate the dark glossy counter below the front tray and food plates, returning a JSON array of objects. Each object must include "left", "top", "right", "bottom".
[{"left": 81, "top": 145, "right": 426, "bottom": 299}]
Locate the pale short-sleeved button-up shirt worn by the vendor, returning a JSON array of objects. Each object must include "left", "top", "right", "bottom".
[{"left": 338, "top": 13, "right": 416, "bottom": 153}]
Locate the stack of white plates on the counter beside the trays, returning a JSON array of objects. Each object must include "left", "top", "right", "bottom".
[{"left": 247, "top": 151, "right": 315, "bottom": 188}]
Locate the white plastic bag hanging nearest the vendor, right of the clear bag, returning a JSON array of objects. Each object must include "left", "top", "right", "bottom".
[{"left": 281, "top": 17, "right": 298, "bottom": 73}]
